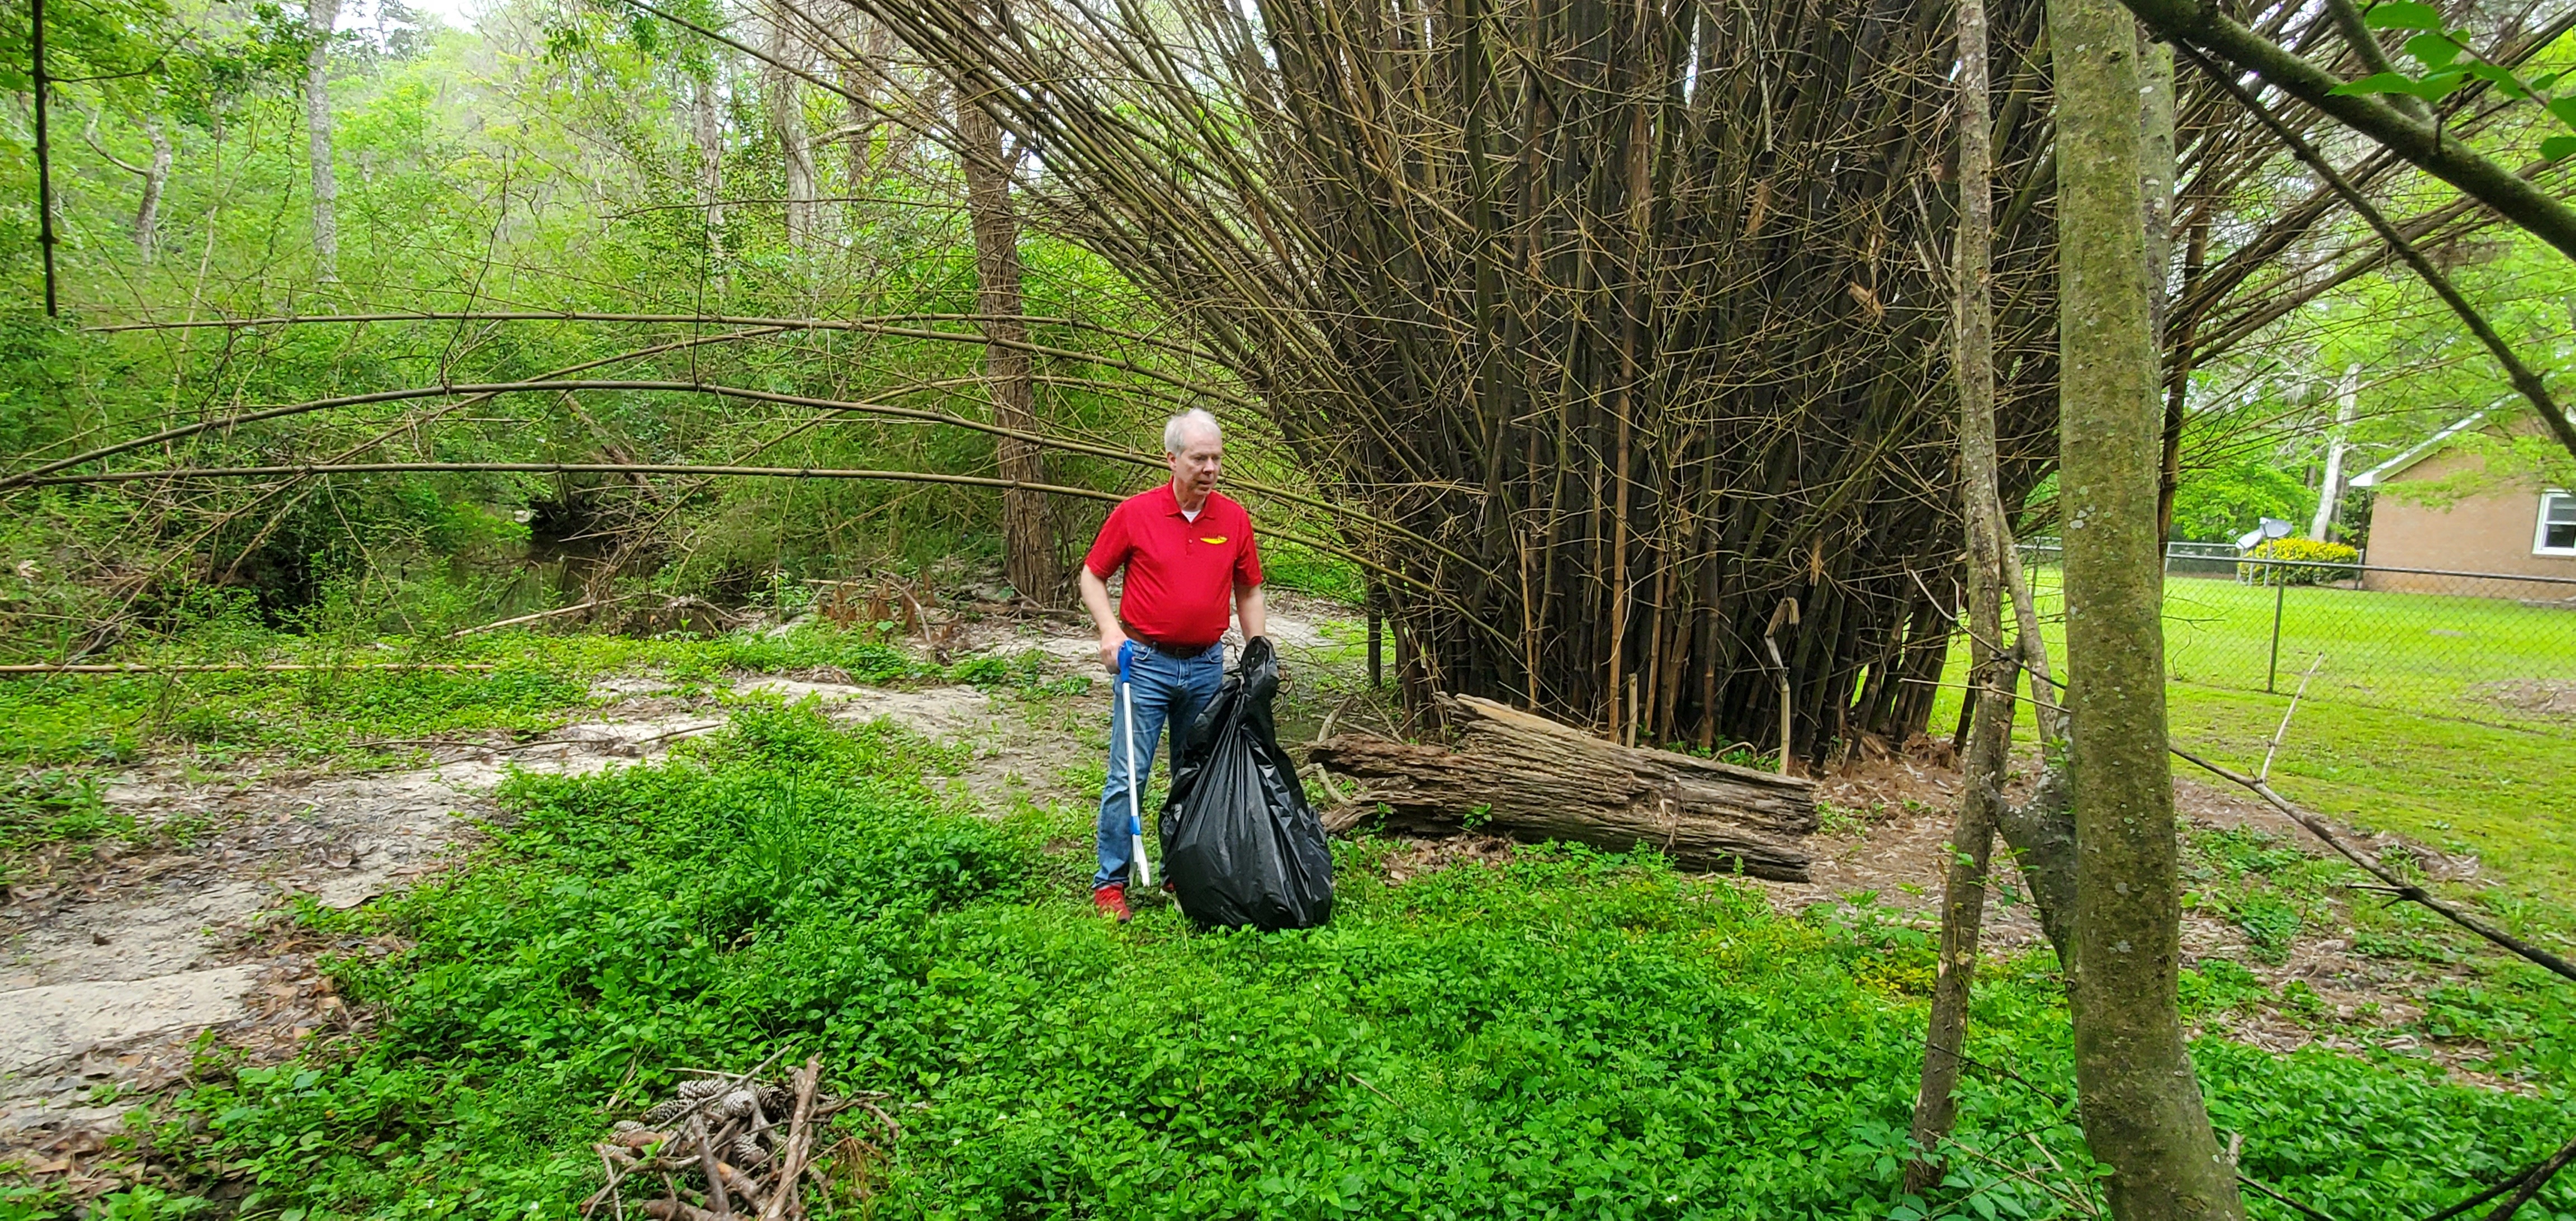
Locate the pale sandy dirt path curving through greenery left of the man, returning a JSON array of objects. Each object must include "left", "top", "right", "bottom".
[{"left": 0, "top": 598, "right": 1370, "bottom": 1180}]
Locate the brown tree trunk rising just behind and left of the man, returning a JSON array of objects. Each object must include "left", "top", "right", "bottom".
[{"left": 956, "top": 98, "right": 1064, "bottom": 603}]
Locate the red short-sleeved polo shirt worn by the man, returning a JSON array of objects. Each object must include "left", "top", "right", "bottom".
[{"left": 1082, "top": 484, "right": 1262, "bottom": 647}]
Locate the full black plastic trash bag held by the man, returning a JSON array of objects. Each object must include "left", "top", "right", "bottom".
[{"left": 1159, "top": 636, "right": 1332, "bottom": 933}]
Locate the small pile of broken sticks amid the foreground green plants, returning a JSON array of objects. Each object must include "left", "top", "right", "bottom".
[{"left": 582, "top": 1059, "right": 902, "bottom": 1221}]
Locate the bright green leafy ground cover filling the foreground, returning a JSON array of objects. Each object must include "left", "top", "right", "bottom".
[{"left": 100, "top": 708, "right": 2576, "bottom": 1218}]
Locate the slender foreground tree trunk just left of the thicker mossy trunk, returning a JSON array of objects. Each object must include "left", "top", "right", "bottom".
[{"left": 1906, "top": 0, "right": 2014, "bottom": 1192}]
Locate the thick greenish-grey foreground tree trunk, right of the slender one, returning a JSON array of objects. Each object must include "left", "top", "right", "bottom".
[{"left": 2048, "top": 0, "right": 2244, "bottom": 1221}]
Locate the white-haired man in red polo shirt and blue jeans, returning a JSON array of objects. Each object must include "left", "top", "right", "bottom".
[{"left": 1082, "top": 410, "right": 1267, "bottom": 925}]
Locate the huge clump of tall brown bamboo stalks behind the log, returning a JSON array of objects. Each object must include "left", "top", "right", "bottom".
[{"left": 853, "top": 0, "right": 2540, "bottom": 760}]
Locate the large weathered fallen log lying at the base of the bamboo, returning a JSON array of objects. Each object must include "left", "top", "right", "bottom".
[{"left": 1306, "top": 695, "right": 1816, "bottom": 881}]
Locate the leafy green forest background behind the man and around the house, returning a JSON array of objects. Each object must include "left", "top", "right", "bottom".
[{"left": 15, "top": 3, "right": 2576, "bottom": 638}]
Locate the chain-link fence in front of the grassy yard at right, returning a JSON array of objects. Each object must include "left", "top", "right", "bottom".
[{"left": 2022, "top": 538, "right": 2576, "bottom": 726}]
